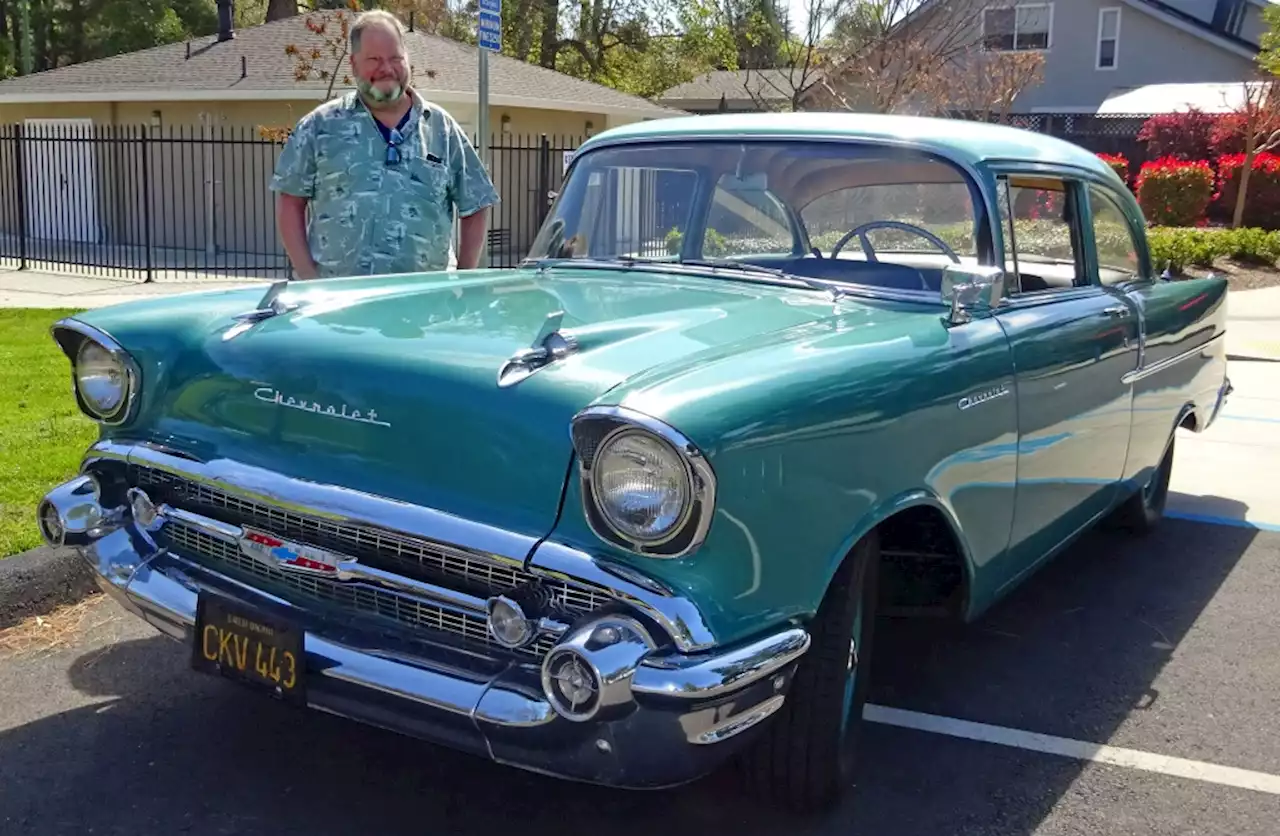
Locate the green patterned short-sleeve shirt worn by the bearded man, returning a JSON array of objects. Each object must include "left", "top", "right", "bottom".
[{"left": 270, "top": 91, "right": 498, "bottom": 278}]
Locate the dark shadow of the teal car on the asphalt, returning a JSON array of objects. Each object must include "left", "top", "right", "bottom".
[{"left": 0, "top": 504, "right": 1258, "bottom": 836}]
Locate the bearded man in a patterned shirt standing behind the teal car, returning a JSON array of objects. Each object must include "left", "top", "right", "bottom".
[{"left": 271, "top": 12, "right": 498, "bottom": 279}]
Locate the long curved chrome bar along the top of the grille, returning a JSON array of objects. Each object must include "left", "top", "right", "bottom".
[{"left": 81, "top": 439, "right": 717, "bottom": 653}]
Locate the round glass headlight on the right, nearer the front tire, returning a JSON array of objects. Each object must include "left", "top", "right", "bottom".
[{"left": 591, "top": 430, "right": 692, "bottom": 543}]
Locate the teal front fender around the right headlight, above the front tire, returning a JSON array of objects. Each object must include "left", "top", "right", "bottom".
[{"left": 553, "top": 303, "right": 1016, "bottom": 641}]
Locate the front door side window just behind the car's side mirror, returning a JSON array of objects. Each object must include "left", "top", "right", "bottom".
[{"left": 998, "top": 174, "right": 1089, "bottom": 293}]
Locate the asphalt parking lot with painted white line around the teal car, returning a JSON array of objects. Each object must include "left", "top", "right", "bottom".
[{"left": 0, "top": 364, "right": 1280, "bottom": 836}]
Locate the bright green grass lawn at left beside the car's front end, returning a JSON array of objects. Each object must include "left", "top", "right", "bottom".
[{"left": 0, "top": 309, "right": 97, "bottom": 558}]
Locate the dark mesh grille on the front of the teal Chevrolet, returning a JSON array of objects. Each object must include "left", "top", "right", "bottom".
[{"left": 129, "top": 466, "right": 612, "bottom": 658}]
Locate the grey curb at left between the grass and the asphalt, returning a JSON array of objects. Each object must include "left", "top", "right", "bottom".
[{"left": 0, "top": 545, "right": 97, "bottom": 630}]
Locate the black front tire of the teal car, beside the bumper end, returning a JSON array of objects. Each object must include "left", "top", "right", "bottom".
[{"left": 742, "top": 531, "right": 879, "bottom": 813}]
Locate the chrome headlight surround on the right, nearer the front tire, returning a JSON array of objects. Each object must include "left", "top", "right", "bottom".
[{"left": 571, "top": 406, "right": 716, "bottom": 559}]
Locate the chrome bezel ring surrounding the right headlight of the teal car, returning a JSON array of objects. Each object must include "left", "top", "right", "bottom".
[{"left": 571, "top": 406, "right": 716, "bottom": 559}]
